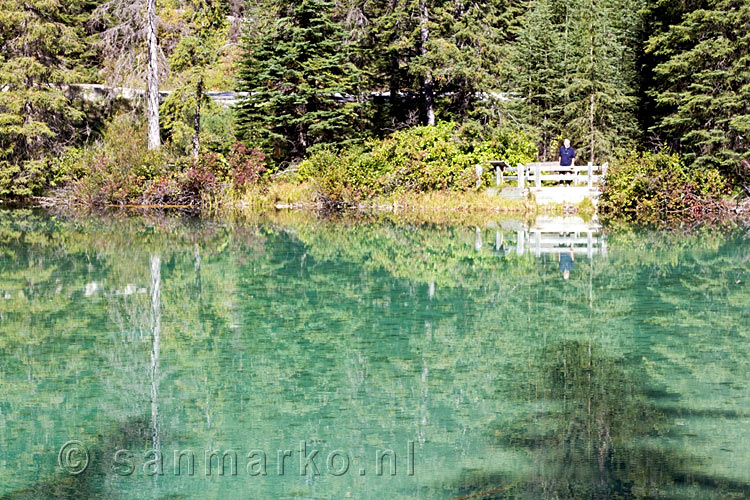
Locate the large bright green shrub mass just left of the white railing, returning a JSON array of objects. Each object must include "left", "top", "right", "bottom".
[{"left": 298, "top": 122, "right": 534, "bottom": 203}]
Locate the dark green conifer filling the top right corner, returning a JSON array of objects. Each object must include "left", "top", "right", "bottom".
[{"left": 646, "top": 0, "right": 750, "bottom": 173}]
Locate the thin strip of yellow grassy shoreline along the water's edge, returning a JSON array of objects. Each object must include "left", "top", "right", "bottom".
[{"left": 16, "top": 183, "right": 750, "bottom": 227}]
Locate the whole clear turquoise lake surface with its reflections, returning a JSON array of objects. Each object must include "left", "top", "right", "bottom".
[{"left": 0, "top": 211, "right": 750, "bottom": 499}]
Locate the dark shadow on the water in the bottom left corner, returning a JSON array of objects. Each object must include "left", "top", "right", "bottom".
[{"left": 0, "top": 417, "right": 152, "bottom": 500}]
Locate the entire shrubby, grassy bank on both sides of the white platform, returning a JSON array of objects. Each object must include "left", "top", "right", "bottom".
[{"left": 23, "top": 115, "right": 747, "bottom": 225}]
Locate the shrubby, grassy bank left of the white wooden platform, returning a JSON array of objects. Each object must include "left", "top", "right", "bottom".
[{"left": 42, "top": 116, "right": 552, "bottom": 218}]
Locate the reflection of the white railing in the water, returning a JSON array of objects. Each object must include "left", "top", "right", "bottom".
[{"left": 474, "top": 217, "right": 607, "bottom": 259}]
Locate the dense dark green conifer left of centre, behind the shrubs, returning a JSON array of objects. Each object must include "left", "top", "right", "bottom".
[{"left": 238, "top": 0, "right": 359, "bottom": 160}]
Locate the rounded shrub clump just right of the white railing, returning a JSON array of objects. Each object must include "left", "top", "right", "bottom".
[{"left": 599, "top": 152, "right": 729, "bottom": 224}]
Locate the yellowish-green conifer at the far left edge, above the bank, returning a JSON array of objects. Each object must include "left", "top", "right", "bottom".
[{"left": 0, "top": 0, "right": 92, "bottom": 197}]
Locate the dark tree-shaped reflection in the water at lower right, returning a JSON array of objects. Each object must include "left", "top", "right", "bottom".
[{"left": 446, "top": 341, "right": 750, "bottom": 499}]
